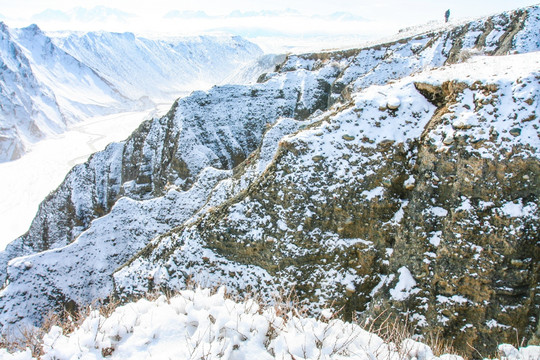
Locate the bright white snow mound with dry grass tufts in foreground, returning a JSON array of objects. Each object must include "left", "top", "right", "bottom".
[{"left": 0, "top": 287, "right": 540, "bottom": 360}]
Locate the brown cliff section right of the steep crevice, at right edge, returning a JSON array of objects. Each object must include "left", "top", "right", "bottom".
[{"left": 371, "top": 74, "right": 540, "bottom": 356}]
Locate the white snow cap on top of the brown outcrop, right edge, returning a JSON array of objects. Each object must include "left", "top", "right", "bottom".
[{"left": 415, "top": 52, "right": 540, "bottom": 159}]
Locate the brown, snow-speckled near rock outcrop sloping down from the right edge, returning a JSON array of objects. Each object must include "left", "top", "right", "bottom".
[{"left": 115, "top": 56, "right": 540, "bottom": 357}]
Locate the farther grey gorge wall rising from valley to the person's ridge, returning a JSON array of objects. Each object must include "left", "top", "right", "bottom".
[{"left": 9, "top": 0, "right": 538, "bottom": 270}]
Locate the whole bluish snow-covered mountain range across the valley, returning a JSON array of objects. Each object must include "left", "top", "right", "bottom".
[{"left": 0, "top": 23, "right": 262, "bottom": 161}]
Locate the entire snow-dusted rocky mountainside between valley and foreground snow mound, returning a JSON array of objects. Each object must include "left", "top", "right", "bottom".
[{"left": 0, "top": 7, "right": 540, "bottom": 357}]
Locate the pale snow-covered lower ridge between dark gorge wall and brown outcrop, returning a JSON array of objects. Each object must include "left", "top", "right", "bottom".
[{"left": 0, "top": 168, "right": 232, "bottom": 330}]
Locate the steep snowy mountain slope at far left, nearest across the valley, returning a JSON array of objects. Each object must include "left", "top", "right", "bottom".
[{"left": 0, "top": 24, "right": 138, "bottom": 161}]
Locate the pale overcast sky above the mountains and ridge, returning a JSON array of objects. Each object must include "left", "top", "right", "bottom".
[{"left": 0, "top": 0, "right": 538, "bottom": 52}]
